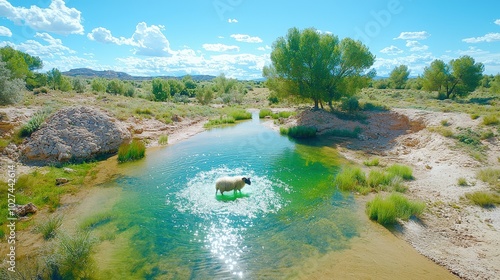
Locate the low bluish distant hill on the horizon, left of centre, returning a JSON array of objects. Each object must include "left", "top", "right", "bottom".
[{"left": 62, "top": 68, "right": 215, "bottom": 81}]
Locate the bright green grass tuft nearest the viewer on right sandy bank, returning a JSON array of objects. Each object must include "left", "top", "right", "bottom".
[{"left": 366, "top": 193, "right": 425, "bottom": 226}]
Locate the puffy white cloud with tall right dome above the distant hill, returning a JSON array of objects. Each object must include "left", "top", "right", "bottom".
[{"left": 87, "top": 22, "right": 173, "bottom": 56}]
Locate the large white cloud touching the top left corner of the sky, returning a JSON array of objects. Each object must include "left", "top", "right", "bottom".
[{"left": 0, "top": 0, "right": 84, "bottom": 35}]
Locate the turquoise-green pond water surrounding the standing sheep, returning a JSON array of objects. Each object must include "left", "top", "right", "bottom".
[{"left": 97, "top": 112, "right": 358, "bottom": 279}]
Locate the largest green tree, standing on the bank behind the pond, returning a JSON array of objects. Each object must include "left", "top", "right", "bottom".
[{"left": 263, "top": 28, "right": 375, "bottom": 109}]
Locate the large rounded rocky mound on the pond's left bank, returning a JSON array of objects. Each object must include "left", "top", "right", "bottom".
[{"left": 21, "top": 106, "right": 131, "bottom": 164}]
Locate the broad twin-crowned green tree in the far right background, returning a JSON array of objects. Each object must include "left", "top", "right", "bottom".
[{"left": 422, "top": 55, "right": 484, "bottom": 98}]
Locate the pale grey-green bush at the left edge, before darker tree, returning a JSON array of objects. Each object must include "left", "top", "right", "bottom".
[{"left": 0, "top": 61, "right": 25, "bottom": 106}]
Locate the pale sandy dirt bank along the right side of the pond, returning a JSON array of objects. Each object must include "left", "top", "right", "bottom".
[{"left": 287, "top": 109, "right": 500, "bottom": 279}]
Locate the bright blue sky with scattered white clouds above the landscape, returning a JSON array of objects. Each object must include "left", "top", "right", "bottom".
[{"left": 0, "top": 0, "right": 500, "bottom": 79}]
